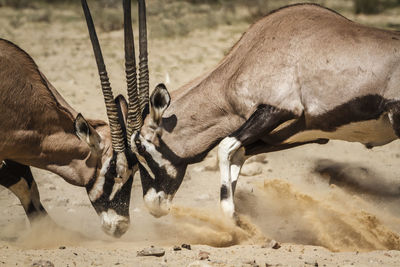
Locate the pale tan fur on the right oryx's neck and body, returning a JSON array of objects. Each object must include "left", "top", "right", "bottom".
[{"left": 141, "top": 5, "right": 400, "bottom": 158}]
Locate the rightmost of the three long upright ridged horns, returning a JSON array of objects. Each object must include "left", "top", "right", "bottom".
[{"left": 138, "top": 0, "right": 149, "bottom": 119}]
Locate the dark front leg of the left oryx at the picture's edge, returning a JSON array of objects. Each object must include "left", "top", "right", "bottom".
[{"left": 0, "top": 160, "right": 47, "bottom": 223}]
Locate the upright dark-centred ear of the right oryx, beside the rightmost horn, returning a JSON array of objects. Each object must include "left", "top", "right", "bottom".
[{"left": 150, "top": 83, "right": 171, "bottom": 126}]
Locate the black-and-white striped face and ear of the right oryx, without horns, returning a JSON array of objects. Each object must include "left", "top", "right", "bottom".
[{"left": 131, "top": 84, "right": 187, "bottom": 217}]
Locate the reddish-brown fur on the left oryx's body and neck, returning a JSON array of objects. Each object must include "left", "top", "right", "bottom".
[{"left": 0, "top": 39, "right": 112, "bottom": 186}]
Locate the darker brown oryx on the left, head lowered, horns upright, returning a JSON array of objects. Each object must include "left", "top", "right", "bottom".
[{"left": 0, "top": 0, "right": 147, "bottom": 237}]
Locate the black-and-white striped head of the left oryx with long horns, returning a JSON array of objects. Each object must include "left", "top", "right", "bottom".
[{"left": 75, "top": 0, "right": 148, "bottom": 237}]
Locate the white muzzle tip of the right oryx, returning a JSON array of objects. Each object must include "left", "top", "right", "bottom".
[{"left": 143, "top": 188, "right": 172, "bottom": 218}]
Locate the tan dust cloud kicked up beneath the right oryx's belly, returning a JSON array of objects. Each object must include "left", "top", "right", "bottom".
[{"left": 236, "top": 174, "right": 400, "bottom": 251}]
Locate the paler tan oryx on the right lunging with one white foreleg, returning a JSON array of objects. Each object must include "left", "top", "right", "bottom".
[{"left": 131, "top": 4, "right": 400, "bottom": 220}]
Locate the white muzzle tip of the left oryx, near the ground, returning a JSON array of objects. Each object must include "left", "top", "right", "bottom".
[{"left": 100, "top": 209, "right": 129, "bottom": 236}]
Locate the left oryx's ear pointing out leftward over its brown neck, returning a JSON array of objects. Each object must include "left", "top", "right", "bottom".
[{"left": 74, "top": 113, "right": 101, "bottom": 151}]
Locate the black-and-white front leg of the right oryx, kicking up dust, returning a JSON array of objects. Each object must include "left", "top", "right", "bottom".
[{"left": 218, "top": 105, "right": 294, "bottom": 217}]
